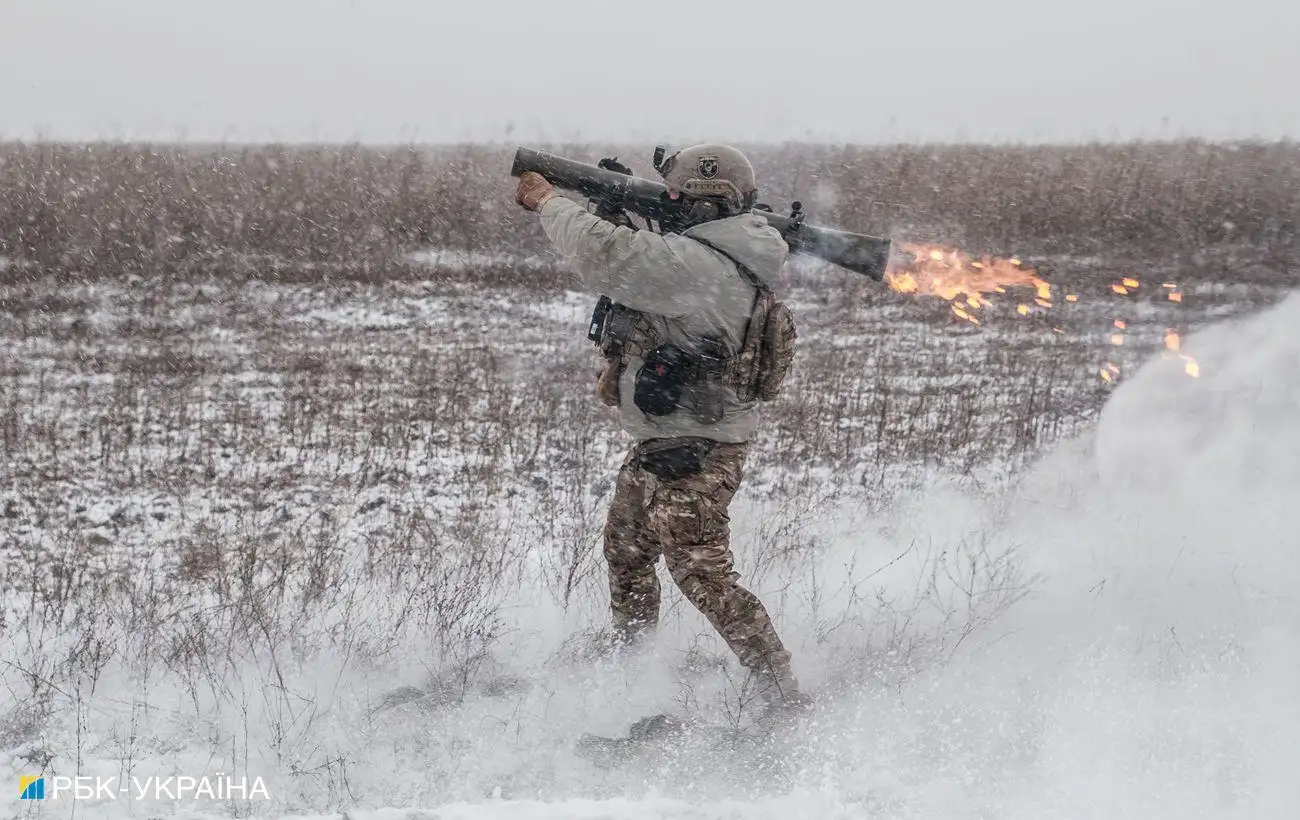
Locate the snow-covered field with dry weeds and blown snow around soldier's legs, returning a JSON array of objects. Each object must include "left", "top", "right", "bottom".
[{"left": 0, "top": 245, "right": 1300, "bottom": 820}]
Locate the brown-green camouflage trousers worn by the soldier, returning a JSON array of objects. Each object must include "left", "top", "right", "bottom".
[{"left": 605, "top": 443, "right": 793, "bottom": 685}]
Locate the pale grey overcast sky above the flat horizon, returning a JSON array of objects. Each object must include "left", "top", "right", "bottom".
[{"left": 0, "top": 0, "right": 1300, "bottom": 143}]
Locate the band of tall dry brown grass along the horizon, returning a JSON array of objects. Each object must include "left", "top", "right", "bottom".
[{"left": 0, "top": 142, "right": 1300, "bottom": 277}]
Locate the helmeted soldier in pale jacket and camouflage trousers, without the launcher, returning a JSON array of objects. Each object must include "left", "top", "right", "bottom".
[{"left": 516, "top": 144, "right": 807, "bottom": 708}]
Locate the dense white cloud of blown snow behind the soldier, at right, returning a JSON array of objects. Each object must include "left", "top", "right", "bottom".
[{"left": 754, "top": 288, "right": 1300, "bottom": 817}]
